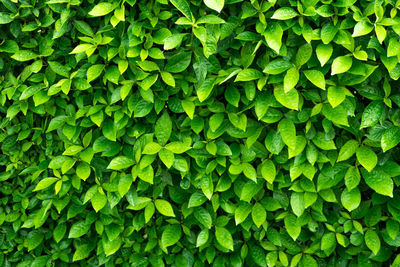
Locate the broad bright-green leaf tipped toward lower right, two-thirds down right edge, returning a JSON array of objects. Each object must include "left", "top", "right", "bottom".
[{"left": 361, "top": 169, "right": 393, "bottom": 197}]
